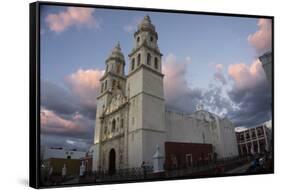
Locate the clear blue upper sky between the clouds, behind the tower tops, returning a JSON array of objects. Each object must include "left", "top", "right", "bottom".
[{"left": 41, "top": 6, "right": 257, "bottom": 88}]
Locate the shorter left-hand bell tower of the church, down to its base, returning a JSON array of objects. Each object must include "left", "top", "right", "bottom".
[{"left": 93, "top": 42, "right": 126, "bottom": 171}]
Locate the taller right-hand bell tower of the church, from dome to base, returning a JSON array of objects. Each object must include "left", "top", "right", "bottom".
[{"left": 126, "top": 16, "right": 165, "bottom": 167}]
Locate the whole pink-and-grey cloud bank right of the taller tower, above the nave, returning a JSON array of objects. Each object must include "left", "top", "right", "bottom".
[{"left": 163, "top": 52, "right": 272, "bottom": 127}]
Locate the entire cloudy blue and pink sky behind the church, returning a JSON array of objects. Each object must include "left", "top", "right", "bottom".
[{"left": 40, "top": 6, "right": 271, "bottom": 150}]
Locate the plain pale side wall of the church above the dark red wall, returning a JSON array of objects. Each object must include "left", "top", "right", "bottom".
[{"left": 165, "top": 110, "right": 238, "bottom": 158}]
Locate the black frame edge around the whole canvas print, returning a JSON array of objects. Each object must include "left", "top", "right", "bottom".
[{"left": 29, "top": 1, "right": 275, "bottom": 189}]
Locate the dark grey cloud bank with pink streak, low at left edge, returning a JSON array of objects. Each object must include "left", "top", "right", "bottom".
[{"left": 40, "top": 77, "right": 96, "bottom": 148}]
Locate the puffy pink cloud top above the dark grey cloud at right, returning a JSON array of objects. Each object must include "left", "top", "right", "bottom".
[{"left": 228, "top": 59, "right": 265, "bottom": 90}]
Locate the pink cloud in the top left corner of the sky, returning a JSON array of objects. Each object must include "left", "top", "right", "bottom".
[{"left": 46, "top": 7, "right": 98, "bottom": 33}]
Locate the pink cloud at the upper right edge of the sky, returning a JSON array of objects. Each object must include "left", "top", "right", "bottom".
[{"left": 248, "top": 19, "right": 272, "bottom": 54}]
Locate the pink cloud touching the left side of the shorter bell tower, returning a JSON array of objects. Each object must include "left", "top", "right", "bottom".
[{"left": 66, "top": 69, "right": 104, "bottom": 108}]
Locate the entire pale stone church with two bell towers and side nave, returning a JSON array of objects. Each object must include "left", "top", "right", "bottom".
[{"left": 92, "top": 16, "right": 238, "bottom": 171}]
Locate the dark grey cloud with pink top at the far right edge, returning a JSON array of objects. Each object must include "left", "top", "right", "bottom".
[{"left": 225, "top": 60, "right": 272, "bottom": 127}]
